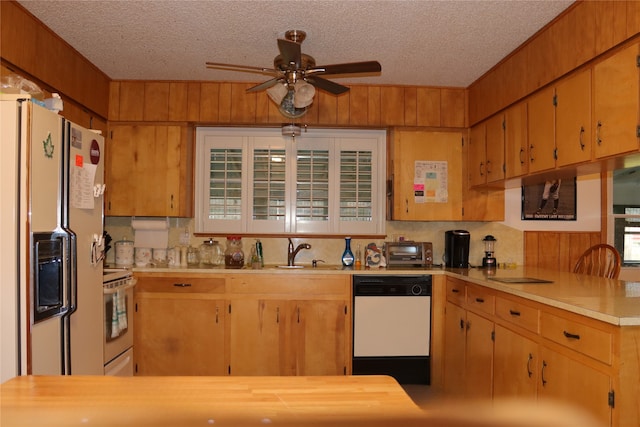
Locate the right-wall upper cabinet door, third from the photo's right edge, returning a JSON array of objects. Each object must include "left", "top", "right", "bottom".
[{"left": 527, "top": 87, "right": 556, "bottom": 173}]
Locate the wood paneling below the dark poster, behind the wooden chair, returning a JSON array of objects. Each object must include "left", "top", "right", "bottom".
[{"left": 524, "top": 231, "right": 605, "bottom": 271}]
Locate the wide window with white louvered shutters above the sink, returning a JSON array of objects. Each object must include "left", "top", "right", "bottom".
[{"left": 195, "top": 127, "right": 386, "bottom": 235}]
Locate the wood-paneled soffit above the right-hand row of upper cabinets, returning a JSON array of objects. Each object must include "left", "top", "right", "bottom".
[{"left": 468, "top": 0, "right": 640, "bottom": 125}]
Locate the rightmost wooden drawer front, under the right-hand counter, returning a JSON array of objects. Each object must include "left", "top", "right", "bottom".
[{"left": 540, "top": 311, "right": 613, "bottom": 364}]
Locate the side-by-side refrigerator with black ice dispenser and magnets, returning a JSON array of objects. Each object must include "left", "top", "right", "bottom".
[{"left": 0, "top": 94, "right": 104, "bottom": 381}]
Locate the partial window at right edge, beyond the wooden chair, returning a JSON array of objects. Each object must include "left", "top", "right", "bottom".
[{"left": 612, "top": 167, "right": 640, "bottom": 266}]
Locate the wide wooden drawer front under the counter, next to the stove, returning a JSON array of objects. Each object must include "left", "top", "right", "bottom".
[{"left": 135, "top": 277, "right": 225, "bottom": 294}]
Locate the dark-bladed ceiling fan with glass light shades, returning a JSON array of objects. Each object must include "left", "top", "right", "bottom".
[{"left": 206, "top": 30, "right": 382, "bottom": 118}]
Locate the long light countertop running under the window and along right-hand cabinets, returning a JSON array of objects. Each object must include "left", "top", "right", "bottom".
[{"left": 127, "top": 264, "right": 640, "bottom": 326}]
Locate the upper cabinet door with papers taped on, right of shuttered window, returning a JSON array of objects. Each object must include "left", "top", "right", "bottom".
[{"left": 390, "top": 130, "right": 462, "bottom": 221}]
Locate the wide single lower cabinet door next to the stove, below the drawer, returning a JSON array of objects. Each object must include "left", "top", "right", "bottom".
[{"left": 134, "top": 293, "right": 227, "bottom": 375}]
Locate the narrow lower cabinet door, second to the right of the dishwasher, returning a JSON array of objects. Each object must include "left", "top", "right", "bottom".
[{"left": 465, "top": 311, "right": 493, "bottom": 399}]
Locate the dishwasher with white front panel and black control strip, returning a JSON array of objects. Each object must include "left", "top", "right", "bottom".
[{"left": 353, "top": 274, "right": 432, "bottom": 384}]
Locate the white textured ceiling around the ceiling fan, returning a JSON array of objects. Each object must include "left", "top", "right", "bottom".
[{"left": 20, "top": 0, "right": 573, "bottom": 87}]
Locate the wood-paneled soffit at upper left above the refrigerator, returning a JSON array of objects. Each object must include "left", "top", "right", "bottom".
[{"left": 0, "top": 0, "right": 110, "bottom": 120}]
